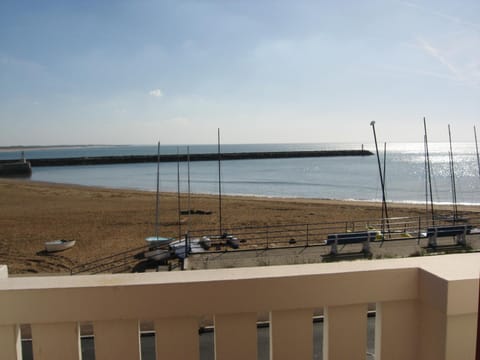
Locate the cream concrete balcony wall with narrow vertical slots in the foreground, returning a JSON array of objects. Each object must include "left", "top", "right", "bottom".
[{"left": 0, "top": 254, "right": 480, "bottom": 360}]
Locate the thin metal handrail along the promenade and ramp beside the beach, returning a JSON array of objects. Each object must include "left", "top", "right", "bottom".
[{"left": 70, "top": 216, "right": 480, "bottom": 275}]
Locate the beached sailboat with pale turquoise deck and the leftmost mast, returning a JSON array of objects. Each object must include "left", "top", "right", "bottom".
[{"left": 144, "top": 142, "right": 174, "bottom": 261}]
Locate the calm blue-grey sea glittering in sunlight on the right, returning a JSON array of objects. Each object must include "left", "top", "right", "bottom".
[{"left": 0, "top": 142, "right": 480, "bottom": 205}]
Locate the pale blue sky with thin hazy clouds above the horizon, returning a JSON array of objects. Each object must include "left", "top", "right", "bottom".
[{"left": 0, "top": 0, "right": 480, "bottom": 146}]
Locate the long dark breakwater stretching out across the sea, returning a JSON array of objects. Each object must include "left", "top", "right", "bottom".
[{"left": 8, "top": 150, "right": 373, "bottom": 167}]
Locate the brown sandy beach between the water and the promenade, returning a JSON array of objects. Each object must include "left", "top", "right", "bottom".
[{"left": 0, "top": 179, "right": 480, "bottom": 274}]
